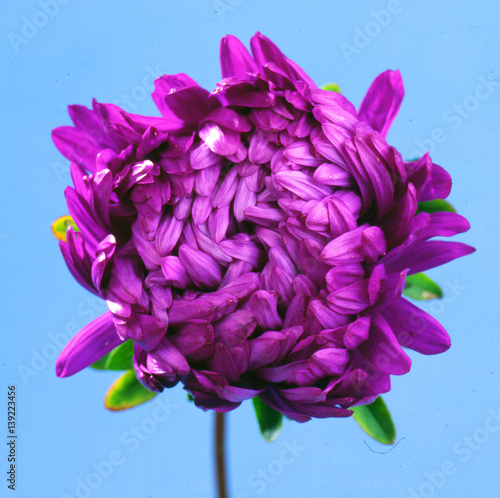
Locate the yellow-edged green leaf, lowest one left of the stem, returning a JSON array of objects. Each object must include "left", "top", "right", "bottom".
[{"left": 104, "top": 370, "right": 156, "bottom": 411}]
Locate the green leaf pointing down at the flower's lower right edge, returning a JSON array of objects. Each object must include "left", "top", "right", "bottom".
[{"left": 350, "top": 396, "right": 396, "bottom": 444}]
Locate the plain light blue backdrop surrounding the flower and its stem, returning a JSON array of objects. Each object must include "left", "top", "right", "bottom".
[{"left": 0, "top": 0, "right": 500, "bottom": 498}]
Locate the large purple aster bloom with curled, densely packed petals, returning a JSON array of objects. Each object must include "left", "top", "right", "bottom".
[{"left": 53, "top": 33, "right": 474, "bottom": 422}]
